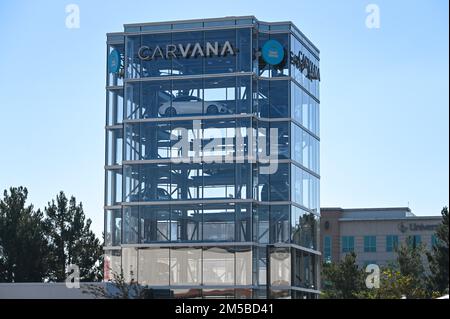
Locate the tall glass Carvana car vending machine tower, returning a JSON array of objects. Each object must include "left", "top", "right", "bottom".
[{"left": 105, "top": 17, "right": 320, "bottom": 298}]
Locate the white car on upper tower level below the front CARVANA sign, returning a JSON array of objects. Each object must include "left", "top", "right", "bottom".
[{"left": 159, "top": 95, "right": 231, "bottom": 116}]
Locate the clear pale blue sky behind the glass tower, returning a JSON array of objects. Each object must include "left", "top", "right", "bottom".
[{"left": 0, "top": 0, "right": 449, "bottom": 234}]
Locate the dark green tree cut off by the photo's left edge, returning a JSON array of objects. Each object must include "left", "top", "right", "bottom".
[{"left": 0, "top": 187, "right": 48, "bottom": 282}]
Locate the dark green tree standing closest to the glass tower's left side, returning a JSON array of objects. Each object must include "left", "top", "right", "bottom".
[{"left": 44, "top": 191, "right": 103, "bottom": 281}]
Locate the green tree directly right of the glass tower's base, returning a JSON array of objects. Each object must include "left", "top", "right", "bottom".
[{"left": 322, "top": 252, "right": 364, "bottom": 299}]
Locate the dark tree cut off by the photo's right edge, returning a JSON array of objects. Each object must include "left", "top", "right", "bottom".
[{"left": 427, "top": 207, "right": 449, "bottom": 293}]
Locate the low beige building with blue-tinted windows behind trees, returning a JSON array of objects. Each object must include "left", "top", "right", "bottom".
[{"left": 320, "top": 207, "right": 441, "bottom": 266}]
